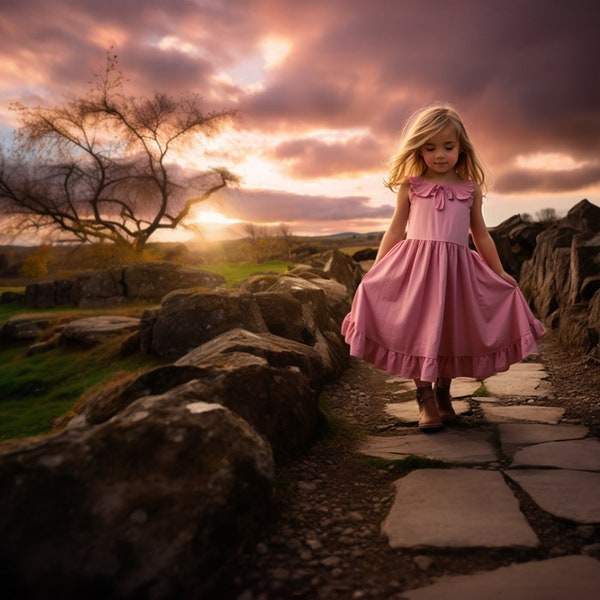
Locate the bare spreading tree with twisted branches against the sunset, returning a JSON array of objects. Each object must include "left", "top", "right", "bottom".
[{"left": 0, "top": 52, "right": 237, "bottom": 251}]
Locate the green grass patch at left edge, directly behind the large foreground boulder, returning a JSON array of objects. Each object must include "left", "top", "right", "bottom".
[{"left": 0, "top": 338, "right": 164, "bottom": 440}]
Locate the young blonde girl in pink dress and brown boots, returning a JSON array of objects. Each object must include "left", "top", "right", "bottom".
[{"left": 342, "top": 106, "right": 543, "bottom": 431}]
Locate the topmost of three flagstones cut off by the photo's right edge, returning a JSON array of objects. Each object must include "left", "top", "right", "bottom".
[{"left": 511, "top": 438, "right": 600, "bottom": 471}]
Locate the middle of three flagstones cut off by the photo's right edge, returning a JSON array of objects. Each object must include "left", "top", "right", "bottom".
[{"left": 505, "top": 469, "right": 600, "bottom": 524}]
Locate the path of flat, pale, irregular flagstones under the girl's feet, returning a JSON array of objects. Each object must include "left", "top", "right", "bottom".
[{"left": 360, "top": 362, "right": 600, "bottom": 600}]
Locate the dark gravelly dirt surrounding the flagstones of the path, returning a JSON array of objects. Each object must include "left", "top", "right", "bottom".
[{"left": 218, "top": 335, "right": 600, "bottom": 600}]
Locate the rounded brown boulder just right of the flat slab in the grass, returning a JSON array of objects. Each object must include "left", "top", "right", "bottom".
[{"left": 141, "top": 289, "right": 268, "bottom": 359}]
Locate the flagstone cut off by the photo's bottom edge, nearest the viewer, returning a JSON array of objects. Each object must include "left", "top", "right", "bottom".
[{"left": 402, "top": 556, "right": 600, "bottom": 600}]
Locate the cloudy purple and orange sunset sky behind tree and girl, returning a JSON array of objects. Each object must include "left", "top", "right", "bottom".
[{"left": 0, "top": 0, "right": 600, "bottom": 239}]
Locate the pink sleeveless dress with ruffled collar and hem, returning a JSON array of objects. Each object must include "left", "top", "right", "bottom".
[{"left": 342, "top": 177, "right": 544, "bottom": 381}]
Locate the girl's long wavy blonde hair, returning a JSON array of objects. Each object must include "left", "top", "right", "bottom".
[{"left": 384, "top": 105, "right": 485, "bottom": 192}]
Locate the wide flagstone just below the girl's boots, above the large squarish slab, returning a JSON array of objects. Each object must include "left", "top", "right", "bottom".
[{"left": 360, "top": 430, "right": 498, "bottom": 464}]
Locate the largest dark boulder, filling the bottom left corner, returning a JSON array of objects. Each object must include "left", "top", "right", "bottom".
[{"left": 0, "top": 394, "right": 274, "bottom": 600}]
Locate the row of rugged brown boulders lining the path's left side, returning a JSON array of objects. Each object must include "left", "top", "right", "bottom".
[{"left": 0, "top": 251, "right": 362, "bottom": 600}]
